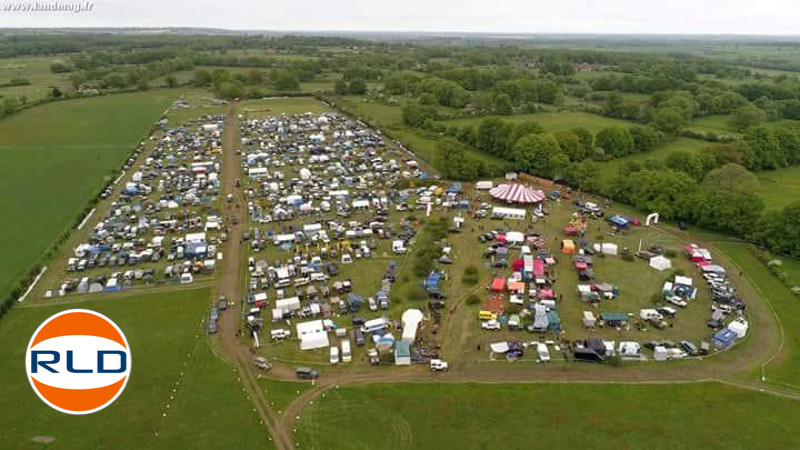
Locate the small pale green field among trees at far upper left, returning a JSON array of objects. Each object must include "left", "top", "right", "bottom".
[{"left": 0, "top": 57, "right": 72, "bottom": 101}]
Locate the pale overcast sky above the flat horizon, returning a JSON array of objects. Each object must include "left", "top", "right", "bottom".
[{"left": 0, "top": 0, "right": 800, "bottom": 35}]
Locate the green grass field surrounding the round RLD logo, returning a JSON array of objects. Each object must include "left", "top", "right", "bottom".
[{"left": 0, "top": 289, "right": 269, "bottom": 449}]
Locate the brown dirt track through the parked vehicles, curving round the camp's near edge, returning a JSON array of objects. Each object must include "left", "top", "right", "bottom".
[{"left": 209, "top": 103, "right": 800, "bottom": 450}]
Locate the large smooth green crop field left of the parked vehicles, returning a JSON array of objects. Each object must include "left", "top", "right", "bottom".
[{"left": 0, "top": 91, "right": 173, "bottom": 298}]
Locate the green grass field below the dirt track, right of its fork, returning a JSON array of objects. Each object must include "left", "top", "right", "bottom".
[{"left": 297, "top": 383, "right": 800, "bottom": 450}]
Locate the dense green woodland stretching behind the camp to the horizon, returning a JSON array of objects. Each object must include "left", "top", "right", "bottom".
[{"left": 0, "top": 34, "right": 800, "bottom": 256}]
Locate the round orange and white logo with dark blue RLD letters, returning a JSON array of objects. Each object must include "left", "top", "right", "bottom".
[{"left": 25, "top": 309, "right": 131, "bottom": 414}]
